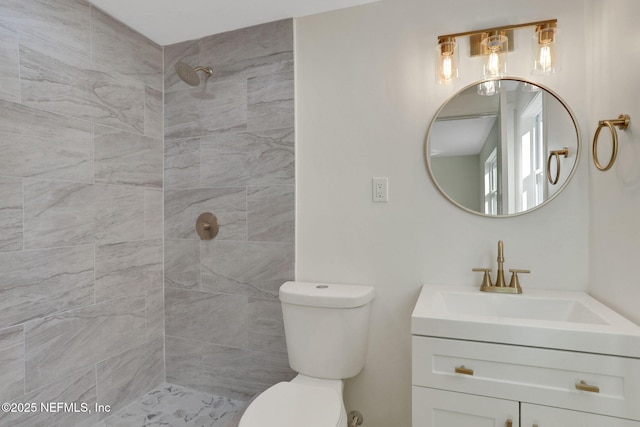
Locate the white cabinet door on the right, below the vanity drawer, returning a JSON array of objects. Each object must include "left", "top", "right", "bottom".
[{"left": 521, "top": 403, "right": 640, "bottom": 427}]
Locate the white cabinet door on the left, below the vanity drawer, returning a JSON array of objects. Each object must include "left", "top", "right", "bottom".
[{"left": 412, "top": 386, "right": 520, "bottom": 427}]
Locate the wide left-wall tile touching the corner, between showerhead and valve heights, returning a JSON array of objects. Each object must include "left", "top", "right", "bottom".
[{"left": 94, "top": 125, "right": 163, "bottom": 188}]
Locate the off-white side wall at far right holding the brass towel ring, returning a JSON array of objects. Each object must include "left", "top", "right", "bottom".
[{"left": 587, "top": 0, "right": 640, "bottom": 322}]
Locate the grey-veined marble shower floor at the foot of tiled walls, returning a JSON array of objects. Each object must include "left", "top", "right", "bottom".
[{"left": 94, "top": 383, "right": 246, "bottom": 427}]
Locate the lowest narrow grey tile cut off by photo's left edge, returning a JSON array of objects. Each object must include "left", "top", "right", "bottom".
[{"left": 0, "top": 325, "right": 24, "bottom": 402}]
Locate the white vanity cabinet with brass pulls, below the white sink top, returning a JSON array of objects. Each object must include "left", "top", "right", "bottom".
[{"left": 412, "top": 335, "right": 640, "bottom": 427}]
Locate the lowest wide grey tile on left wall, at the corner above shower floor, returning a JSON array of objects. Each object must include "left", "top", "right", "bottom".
[{"left": 96, "top": 338, "right": 164, "bottom": 419}]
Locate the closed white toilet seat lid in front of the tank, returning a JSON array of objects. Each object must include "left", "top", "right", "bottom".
[{"left": 239, "top": 382, "right": 346, "bottom": 427}]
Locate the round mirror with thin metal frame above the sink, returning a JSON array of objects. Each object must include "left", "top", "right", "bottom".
[{"left": 426, "top": 78, "right": 580, "bottom": 217}]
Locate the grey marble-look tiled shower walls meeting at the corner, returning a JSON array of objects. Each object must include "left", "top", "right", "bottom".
[{"left": 0, "top": 0, "right": 294, "bottom": 426}]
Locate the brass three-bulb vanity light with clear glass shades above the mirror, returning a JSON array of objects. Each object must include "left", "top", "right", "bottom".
[{"left": 436, "top": 19, "right": 558, "bottom": 84}]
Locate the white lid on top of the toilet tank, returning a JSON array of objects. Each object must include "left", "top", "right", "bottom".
[{"left": 280, "top": 282, "right": 375, "bottom": 308}]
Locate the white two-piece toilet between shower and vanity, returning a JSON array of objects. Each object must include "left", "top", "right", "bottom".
[{"left": 239, "top": 282, "right": 374, "bottom": 427}]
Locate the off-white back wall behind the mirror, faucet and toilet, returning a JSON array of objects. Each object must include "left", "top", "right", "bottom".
[{"left": 295, "top": 0, "right": 592, "bottom": 427}]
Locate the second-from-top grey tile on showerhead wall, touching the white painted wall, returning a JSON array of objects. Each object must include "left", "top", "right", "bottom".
[{"left": 247, "top": 72, "right": 294, "bottom": 130}]
